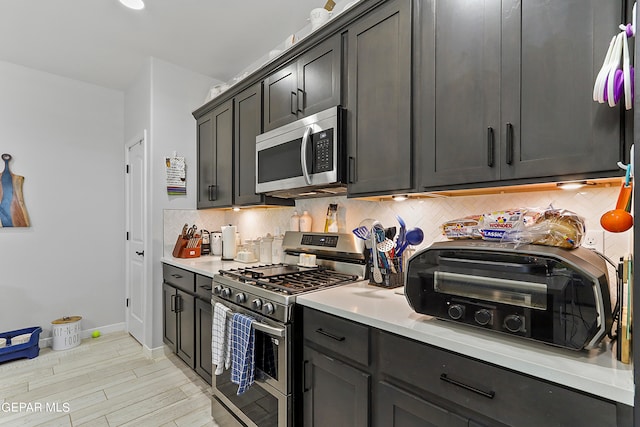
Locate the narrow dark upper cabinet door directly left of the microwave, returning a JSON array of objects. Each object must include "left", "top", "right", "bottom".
[{"left": 234, "top": 84, "right": 262, "bottom": 205}]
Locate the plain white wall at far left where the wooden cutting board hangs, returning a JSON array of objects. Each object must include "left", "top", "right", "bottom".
[{"left": 0, "top": 62, "right": 124, "bottom": 337}]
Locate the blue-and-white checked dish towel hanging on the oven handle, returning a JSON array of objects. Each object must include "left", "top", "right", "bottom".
[{"left": 231, "top": 313, "right": 255, "bottom": 395}]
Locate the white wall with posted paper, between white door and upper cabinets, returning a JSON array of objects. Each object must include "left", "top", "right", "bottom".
[{"left": 125, "top": 58, "right": 216, "bottom": 349}]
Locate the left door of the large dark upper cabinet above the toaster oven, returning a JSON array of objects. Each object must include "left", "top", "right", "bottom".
[{"left": 416, "top": 0, "right": 502, "bottom": 189}]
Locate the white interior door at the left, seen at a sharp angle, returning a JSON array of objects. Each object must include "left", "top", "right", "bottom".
[{"left": 126, "top": 131, "right": 146, "bottom": 343}]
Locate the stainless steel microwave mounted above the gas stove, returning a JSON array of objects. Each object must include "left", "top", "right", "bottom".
[{"left": 256, "top": 106, "right": 346, "bottom": 198}]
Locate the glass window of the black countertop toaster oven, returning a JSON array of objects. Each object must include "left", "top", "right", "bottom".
[{"left": 433, "top": 271, "right": 547, "bottom": 310}]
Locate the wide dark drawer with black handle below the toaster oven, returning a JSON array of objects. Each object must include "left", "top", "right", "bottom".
[{"left": 378, "top": 333, "right": 616, "bottom": 427}]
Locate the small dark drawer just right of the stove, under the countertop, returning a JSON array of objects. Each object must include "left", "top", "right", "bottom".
[{"left": 304, "top": 308, "right": 369, "bottom": 366}]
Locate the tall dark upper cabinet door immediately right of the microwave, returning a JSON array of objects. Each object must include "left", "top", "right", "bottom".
[{"left": 347, "top": 0, "right": 412, "bottom": 196}]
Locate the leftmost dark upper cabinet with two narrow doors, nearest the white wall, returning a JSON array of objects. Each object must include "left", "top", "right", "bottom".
[{"left": 197, "top": 101, "right": 233, "bottom": 209}]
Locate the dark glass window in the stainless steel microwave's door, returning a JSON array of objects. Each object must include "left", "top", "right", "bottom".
[{"left": 258, "top": 138, "right": 302, "bottom": 183}]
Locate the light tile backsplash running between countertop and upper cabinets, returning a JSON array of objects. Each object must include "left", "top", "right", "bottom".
[{"left": 164, "top": 187, "right": 632, "bottom": 261}]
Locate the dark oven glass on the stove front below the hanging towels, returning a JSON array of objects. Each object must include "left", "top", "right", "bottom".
[{"left": 214, "top": 369, "right": 278, "bottom": 427}]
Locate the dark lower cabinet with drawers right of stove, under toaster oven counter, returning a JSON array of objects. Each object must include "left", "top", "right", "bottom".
[{"left": 303, "top": 307, "right": 633, "bottom": 427}]
